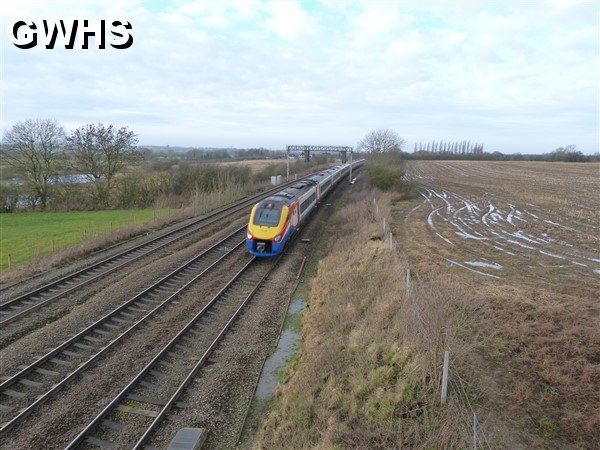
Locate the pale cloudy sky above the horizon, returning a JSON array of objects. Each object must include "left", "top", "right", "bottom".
[{"left": 0, "top": 0, "right": 600, "bottom": 153}]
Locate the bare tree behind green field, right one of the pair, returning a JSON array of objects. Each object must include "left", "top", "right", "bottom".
[{"left": 67, "top": 124, "right": 138, "bottom": 204}]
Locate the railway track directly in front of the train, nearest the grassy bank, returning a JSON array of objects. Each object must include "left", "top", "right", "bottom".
[{"left": 67, "top": 257, "right": 280, "bottom": 449}]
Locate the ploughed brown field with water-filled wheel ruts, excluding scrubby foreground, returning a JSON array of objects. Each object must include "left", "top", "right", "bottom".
[{"left": 408, "top": 161, "right": 600, "bottom": 281}]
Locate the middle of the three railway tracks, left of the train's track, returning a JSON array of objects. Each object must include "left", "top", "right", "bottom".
[{"left": 0, "top": 226, "right": 246, "bottom": 436}]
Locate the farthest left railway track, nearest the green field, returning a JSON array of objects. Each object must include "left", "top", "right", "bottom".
[{"left": 0, "top": 181, "right": 308, "bottom": 329}]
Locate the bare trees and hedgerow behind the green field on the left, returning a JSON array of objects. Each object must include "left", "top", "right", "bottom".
[{"left": 0, "top": 119, "right": 304, "bottom": 211}]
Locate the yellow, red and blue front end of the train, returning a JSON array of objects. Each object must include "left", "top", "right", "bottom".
[{"left": 246, "top": 197, "right": 294, "bottom": 256}]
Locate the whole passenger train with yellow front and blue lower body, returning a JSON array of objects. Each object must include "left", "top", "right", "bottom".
[{"left": 246, "top": 160, "right": 363, "bottom": 257}]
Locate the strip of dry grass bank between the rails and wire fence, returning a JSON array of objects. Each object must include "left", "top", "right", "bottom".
[{"left": 254, "top": 180, "right": 467, "bottom": 448}]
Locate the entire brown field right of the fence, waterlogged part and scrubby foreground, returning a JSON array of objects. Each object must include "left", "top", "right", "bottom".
[{"left": 394, "top": 161, "right": 600, "bottom": 448}]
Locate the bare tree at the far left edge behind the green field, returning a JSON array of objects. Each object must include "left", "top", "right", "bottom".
[{"left": 1, "top": 119, "right": 65, "bottom": 208}]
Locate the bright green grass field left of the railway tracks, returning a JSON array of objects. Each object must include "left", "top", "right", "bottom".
[{"left": 0, "top": 208, "right": 176, "bottom": 271}]
